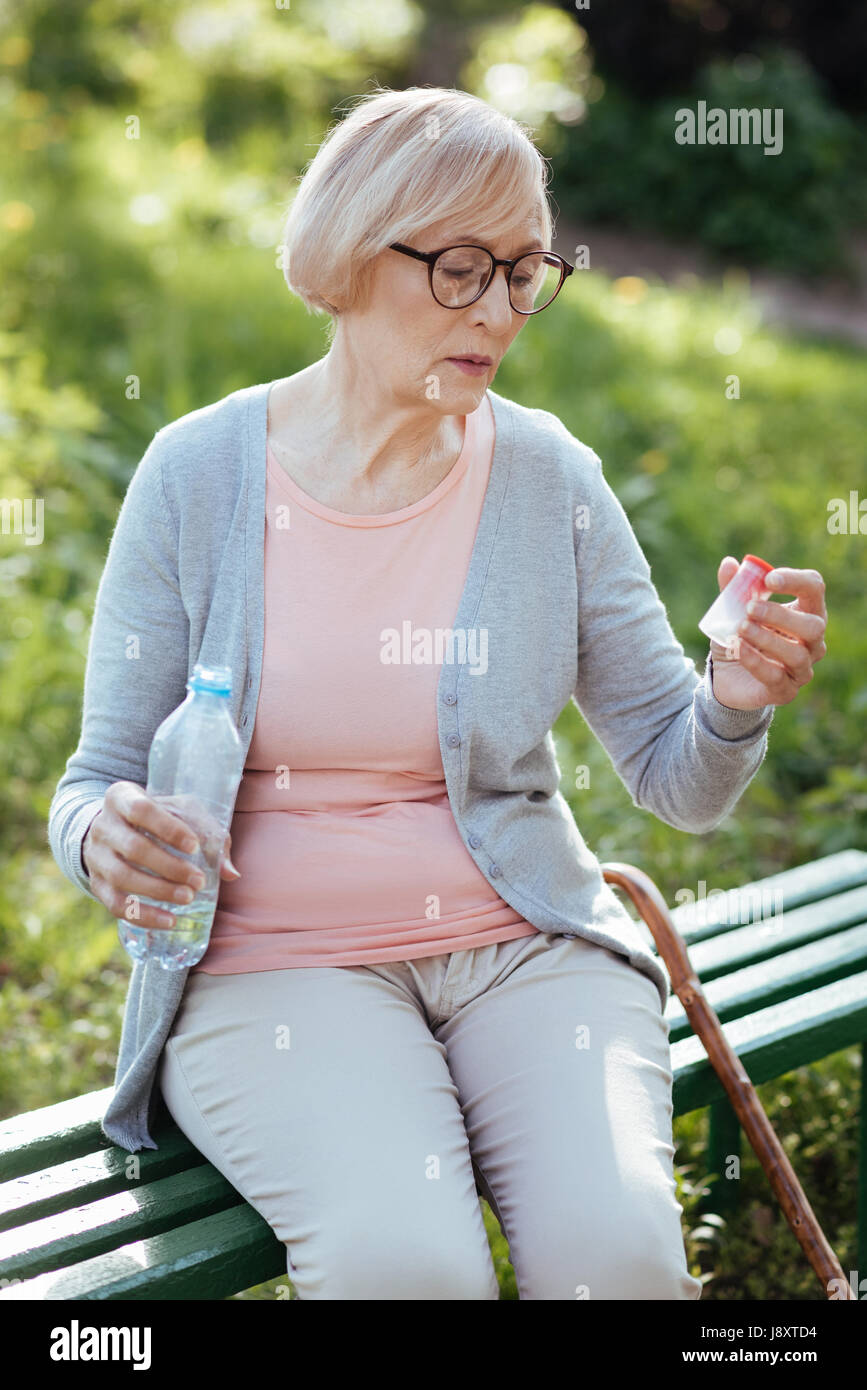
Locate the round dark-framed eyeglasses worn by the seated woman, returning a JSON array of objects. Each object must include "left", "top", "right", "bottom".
[{"left": 390, "top": 242, "right": 575, "bottom": 314}]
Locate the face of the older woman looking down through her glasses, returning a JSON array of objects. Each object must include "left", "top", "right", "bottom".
[{"left": 343, "top": 218, "right": 543, "bottom": 414}]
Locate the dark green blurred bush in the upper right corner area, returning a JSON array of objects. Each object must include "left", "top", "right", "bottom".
[{"left": 553, "top": 50, "right": 867, "bottom": 278}]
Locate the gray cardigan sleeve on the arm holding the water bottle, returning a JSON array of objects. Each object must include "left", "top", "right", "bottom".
[{"left": 47, "top": 431, "right": 189, "bottom": 901}]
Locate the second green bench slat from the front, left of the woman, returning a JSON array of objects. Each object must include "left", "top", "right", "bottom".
[{"left": 0, "top": 1161, "right": 243, "bottom": 1279}]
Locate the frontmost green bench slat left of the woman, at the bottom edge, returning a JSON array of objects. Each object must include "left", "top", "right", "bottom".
[{"left": 0, "top": 1202, "right": 286, "bottom": 1302}]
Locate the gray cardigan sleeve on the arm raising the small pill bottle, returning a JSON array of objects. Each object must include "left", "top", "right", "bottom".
[{"left": 572, "top": 450, "right": 774, "bottom": 834}]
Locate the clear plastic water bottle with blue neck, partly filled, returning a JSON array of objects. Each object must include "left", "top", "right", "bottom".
[{"left": 117, "top": 662, "right": 243, "bottom": 970}]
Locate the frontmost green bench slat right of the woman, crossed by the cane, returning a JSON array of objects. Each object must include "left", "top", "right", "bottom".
[{"left": 671, "top": 970, "right": 867, "bottom": 1115}]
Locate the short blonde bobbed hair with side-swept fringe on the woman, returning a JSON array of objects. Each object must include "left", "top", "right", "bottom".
[{"left": 282, "top": 86, "right": 553, "bottom": 335}]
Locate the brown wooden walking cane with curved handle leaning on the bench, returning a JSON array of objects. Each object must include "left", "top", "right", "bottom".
[{"left": 602, "top": 863, "right": 856, "bottom": 1301}]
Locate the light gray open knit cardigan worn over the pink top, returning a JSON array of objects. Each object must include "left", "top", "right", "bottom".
[{"left": 49, "top": 382, "right": 773, "bottom": 1152}]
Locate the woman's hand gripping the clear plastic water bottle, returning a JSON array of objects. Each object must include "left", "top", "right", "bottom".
[{"left": 82, "top": 781, "right": 213, "bottom": 927}]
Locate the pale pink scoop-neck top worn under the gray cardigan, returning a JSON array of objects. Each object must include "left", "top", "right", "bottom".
[{"left": 193, "top": 395, "right": 538, "bottom": 974}]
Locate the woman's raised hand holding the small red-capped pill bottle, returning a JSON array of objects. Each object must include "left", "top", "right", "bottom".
[{"left": 710, "top": 555, "right": 828, "bottom": 709}]
